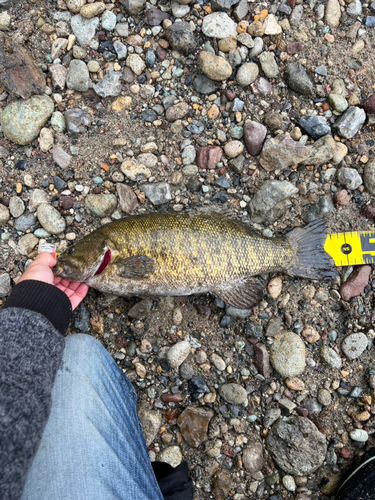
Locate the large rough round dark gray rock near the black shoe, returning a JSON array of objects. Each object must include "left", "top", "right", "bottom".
[{"left": 266, "top": 417, "right": 327, "bottom": 476}]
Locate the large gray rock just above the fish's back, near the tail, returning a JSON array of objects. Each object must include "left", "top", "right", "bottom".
[{"left": 249, "top": 181, "right": 298, "bottom": 224}]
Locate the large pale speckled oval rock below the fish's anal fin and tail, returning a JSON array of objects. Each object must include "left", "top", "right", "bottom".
[{"left": 270, "top": 332, "right": 306, "bottom": 378}]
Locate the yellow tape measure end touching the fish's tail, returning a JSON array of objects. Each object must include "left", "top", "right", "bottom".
[{"left": 324, "top": 231, "right": 375, "bottom": 266}]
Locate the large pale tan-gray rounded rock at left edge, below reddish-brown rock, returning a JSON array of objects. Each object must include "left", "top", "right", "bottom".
[{"left": 0, "top": 95, "right": 54, "bottom": 146}]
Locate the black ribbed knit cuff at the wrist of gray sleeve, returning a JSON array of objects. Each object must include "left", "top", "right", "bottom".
[{"left": 3, "top": 280, "right": 72, "bottom": 335}]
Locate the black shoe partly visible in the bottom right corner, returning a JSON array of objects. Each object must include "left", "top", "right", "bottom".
[{"left": 336, "top": 448, "right": 375, "bottom": 500}]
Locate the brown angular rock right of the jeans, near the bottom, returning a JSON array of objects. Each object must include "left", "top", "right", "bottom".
[{"left": 177, "top": 408, "right": 214, "bottom": 448}]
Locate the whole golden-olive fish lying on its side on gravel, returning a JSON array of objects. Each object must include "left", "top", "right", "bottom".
[{"left": 54, "top": 211, "right": 337, "bottom": 309}]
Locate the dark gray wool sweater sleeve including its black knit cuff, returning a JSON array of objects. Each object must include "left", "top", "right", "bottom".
[{"left": 0, "top": 280, "right": 72, "bottom": 500}]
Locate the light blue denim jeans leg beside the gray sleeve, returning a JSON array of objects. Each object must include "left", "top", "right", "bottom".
[{"left": 22, "top": 335, "right": 163, "bottom": 500}]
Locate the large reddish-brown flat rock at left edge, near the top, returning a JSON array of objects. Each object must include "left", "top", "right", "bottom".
[{"left": 0, "top": 33, "right": 46, "bottom": 99}]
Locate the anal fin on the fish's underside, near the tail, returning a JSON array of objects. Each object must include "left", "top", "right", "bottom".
[{"left": 214, "top": 278, "right": 264, "bottom": 309}]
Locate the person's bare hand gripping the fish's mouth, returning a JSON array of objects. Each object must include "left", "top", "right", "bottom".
[{"left": 17, "top": 252, "right": 89, "bottom": 310}]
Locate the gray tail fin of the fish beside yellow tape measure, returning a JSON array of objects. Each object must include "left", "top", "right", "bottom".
[{"left": 288, "top": 220, "right": 337, "bottom": 280}]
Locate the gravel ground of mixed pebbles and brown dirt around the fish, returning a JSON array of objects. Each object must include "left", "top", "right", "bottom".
[{"left": 0, "top": 0, "right": 375, "bottom": 500}]
